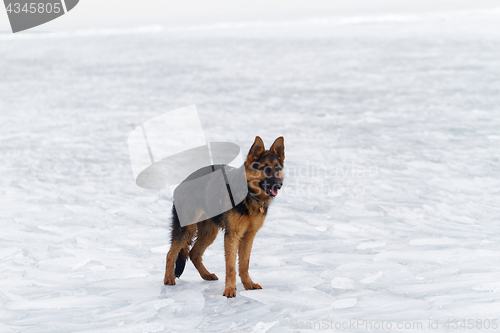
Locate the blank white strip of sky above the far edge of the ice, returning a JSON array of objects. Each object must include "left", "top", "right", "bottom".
[{"left": 0, "top": 0, "right": 498, "bottom": 31}]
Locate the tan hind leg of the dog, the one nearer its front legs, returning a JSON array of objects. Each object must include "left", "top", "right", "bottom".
[{"left": 189, "top": 220, "right": 219, "bottom": 281}]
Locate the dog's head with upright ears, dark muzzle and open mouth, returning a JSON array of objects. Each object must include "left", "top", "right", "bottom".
[{"left": 245, "top": 136, "right": 285, "bottom": 200}]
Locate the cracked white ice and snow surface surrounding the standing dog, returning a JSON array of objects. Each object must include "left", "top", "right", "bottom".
[{"left": 0, "top": 10, "right": 500, "bottom": 333}]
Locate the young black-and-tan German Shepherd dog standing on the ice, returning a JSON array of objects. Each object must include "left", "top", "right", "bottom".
[{"left": 163, "top": 136, "right": 285, "bottom": 298}]
